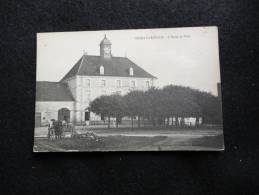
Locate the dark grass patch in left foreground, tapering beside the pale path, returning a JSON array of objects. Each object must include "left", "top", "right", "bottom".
[{"left": 34, "top": 135, "right": 166, "bottom": 152}]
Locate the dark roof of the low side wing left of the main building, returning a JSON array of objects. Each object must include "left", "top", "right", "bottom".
[{"left": 36, "top": 81, "right": 74, "bottom": 101}]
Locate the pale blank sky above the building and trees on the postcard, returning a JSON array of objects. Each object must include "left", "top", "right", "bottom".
[{"left": 36, "top": 27, "right": 220, "bottom": 95}]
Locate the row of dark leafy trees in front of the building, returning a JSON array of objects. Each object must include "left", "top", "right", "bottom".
[{"left": 90, "top": 85, "right": 222, "bottom": 128}]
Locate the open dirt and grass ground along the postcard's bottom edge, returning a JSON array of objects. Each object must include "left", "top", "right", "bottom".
[{"left": 33, "top": 130, "right": 224, "bottom": 152}]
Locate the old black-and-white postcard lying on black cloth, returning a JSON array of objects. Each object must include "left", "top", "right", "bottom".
[{"left": 33, "top": 26, "right": 224, "bottom": 152}]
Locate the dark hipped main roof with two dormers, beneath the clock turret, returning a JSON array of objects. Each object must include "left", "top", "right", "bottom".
[{"left": 61, "top": 55, "right": 156, "bottom": 81}]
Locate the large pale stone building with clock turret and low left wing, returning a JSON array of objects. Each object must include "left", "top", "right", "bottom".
[{"left": 35, "top": 36, "right": 156, "bottom": 126}]
